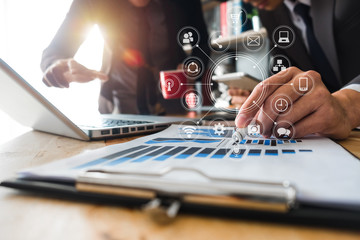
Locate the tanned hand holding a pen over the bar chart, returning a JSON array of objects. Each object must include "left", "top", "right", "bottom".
[{"left": 235, "top": 67, "right": 360, "bottom": 139}]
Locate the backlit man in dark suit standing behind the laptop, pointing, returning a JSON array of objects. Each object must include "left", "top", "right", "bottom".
[{"left": 41, "top": 0, "right": 209, "bottom": 114}]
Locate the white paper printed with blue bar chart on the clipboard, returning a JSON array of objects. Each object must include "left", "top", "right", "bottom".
[{"left": 19, "top": 125, "right": 360, "bottom": 209}]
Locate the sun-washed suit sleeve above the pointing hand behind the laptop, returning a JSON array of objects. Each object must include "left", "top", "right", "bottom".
[{"left": 41, "top": 0, "right": 94, "bottom": 72}]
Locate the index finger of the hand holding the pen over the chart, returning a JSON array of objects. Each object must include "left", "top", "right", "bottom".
[{"left": 235, "top": 67, "right": 301, "bottom": 128}]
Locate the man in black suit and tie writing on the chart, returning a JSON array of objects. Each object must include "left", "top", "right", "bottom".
[{"left": 231, "top": 0, "right": 360, "bottom": 139}]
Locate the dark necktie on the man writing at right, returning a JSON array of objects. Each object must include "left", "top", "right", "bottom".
[{"left": 294, "top": 3, "right": 341, "bottom": 92}]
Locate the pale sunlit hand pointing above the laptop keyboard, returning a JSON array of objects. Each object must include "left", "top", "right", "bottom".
[{"left": 43, "top": 58, "right": 108, "bottom": 88}]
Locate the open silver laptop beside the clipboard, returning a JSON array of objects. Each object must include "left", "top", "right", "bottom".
[{"left": 0, "top": 58, "right": 189, "bottom": 141}]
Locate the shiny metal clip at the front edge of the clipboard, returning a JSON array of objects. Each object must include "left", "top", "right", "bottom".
[{"left": 76, "top": 167, "right": 296, "bottom": 223}]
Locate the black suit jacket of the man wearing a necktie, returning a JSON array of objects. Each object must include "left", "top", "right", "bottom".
[{"left": 259, "top": 0, "right": 360, "bottom": 90}]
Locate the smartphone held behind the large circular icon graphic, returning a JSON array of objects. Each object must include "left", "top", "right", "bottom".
[{"left": 212, "top": 72, "right": 261, "bottom": 91}]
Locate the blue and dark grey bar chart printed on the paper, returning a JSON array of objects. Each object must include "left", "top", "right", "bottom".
[{"left": 71, "top": 138, "right": 313, "bottom": 169}]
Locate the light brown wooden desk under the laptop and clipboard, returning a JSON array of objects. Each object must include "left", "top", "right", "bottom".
[{"left": 0, "top": 122, "right": 360, "bottom": 240}]
